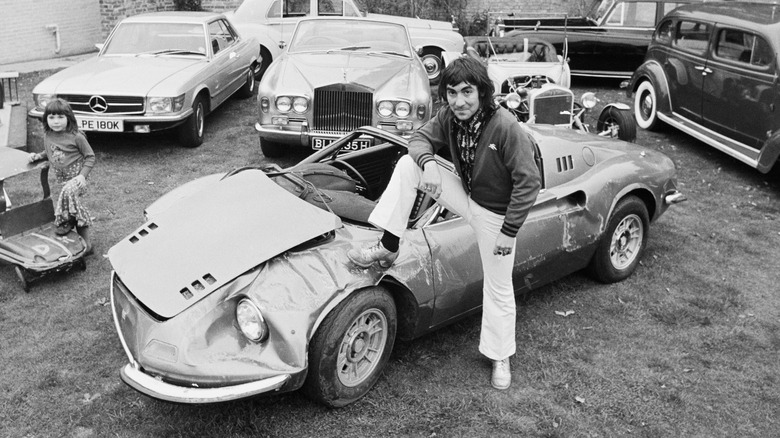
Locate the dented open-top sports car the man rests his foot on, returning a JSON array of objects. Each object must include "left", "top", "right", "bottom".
[{"left": 108, "top": 125, "right": 685, "bottom": 407}]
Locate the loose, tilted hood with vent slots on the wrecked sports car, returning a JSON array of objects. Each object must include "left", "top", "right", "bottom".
[{"left": 108, "top": 170, "right": 341, "bottom": 318}]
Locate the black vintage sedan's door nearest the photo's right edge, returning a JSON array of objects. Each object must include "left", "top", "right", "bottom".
[{"left": 702, "top": 26, "right": 778, "bottom": 152}]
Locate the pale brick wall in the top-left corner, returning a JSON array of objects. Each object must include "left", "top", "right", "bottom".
[{"left": 0, "top": 0, "right": 102, "bottom": 64}]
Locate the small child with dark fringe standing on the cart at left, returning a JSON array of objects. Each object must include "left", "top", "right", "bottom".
[{"left": 30, "top": 99, "right": 95, "bottom": 254}]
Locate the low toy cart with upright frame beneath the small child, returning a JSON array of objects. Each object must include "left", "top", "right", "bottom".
[{"left": 0, "top": 147, "right": 87, "bottom": 292}]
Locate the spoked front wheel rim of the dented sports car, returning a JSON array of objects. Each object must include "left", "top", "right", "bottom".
[{"left": 338, "top": 309, "right": 387, "bottom": 387}]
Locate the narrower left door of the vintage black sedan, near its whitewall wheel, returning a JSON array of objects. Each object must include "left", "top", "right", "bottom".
[{"left": 663, "top": 19, "right": 712, "bottom": 123}]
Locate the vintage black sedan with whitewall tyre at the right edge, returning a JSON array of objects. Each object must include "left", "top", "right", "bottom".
[{"left": 627, "top": 2, "right": 780, "bottom": 173}]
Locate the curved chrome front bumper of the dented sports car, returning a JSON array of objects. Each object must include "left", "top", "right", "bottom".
[{"left": 120, "top": 364, "right": 290, "bottom": 404}]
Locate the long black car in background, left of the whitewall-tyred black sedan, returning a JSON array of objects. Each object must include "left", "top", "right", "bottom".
[{"left": 496, "top": 0, "right": 702, "bottom": 78}]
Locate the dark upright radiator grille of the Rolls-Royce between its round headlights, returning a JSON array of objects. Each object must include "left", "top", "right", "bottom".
[{"left": 312, "top": 89, "right": 374, "bottom": 134}]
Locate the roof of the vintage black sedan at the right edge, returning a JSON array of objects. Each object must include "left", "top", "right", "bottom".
[{"left": 667, "top": 2, "right": 780, "bottom": 27}]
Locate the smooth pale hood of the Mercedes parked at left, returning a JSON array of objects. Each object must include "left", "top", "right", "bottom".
[{"left": 40, "top": 56, "right": 206, "bottom": 96}]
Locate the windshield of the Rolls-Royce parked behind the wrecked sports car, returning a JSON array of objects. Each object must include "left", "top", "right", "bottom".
[{"left": 289, "top": 20, "right": 412, "bottom": 57}]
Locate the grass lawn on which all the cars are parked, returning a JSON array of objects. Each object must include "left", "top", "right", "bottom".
[{"left": 0, "top": 72, "right": 780, "bottom": 438}]
